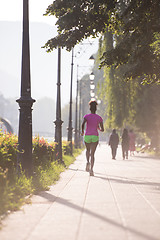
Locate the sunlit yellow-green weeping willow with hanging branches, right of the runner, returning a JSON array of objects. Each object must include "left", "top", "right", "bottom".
[{"left": 99, "top": 32, "right": 136, "bottom": 128}]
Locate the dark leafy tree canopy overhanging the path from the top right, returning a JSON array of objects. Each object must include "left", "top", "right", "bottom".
[{"left": 45, "top": 0, "right": 160, "bottom": 82}]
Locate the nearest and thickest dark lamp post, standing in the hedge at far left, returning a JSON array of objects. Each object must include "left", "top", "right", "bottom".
[{"left": 16, "top": 0, "right": 35, "bottom": 176}]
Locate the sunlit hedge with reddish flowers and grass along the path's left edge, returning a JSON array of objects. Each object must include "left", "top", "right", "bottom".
[{"left": 0, "top": 132, "right": 80, "bottom": 216}]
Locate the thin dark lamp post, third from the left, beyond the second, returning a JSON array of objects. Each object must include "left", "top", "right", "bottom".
[{"left": 67, "top": 49, "right": 74, "bottom": 155}]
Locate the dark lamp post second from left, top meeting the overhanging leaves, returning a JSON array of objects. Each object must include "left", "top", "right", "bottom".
[{"left": 54, "top": 47, "right": 63, "bottom": 162}]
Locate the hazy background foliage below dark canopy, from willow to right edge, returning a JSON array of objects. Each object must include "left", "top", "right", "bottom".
[{"left": 99, "top": 26, "right": 160, "bottom": 148}]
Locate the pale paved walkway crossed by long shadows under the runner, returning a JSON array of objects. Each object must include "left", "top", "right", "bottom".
[{"left": 0, "top": 144, "right": 160, "bottom": 240}]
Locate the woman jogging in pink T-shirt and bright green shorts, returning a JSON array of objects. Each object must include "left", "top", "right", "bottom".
[{"left": 82, "top": 101, "right": 104, "bottom": 176}]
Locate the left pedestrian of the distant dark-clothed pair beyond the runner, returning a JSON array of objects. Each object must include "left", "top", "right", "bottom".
[{"left": 109, "top": 129, "right": 119, "bottom": 160}]
